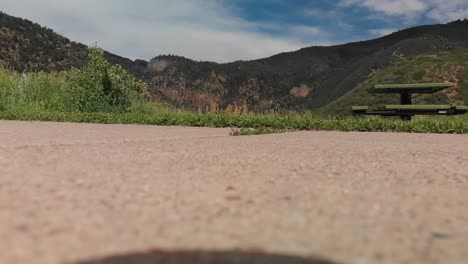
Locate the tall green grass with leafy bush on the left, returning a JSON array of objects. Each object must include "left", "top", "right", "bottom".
[{"left": 0, "top": 48, "right": 146, "bottom": 112}]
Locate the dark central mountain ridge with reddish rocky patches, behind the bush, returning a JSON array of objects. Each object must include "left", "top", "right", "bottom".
[{"left": 144, "top": 21, "right": 468, "bottom": 111}]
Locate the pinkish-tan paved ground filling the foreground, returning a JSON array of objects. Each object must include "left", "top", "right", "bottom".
[{"left": 0, "top": 121, "right": 468, "bottom": 264}]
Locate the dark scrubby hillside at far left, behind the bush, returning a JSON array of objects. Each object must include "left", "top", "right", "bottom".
[{"left": 0, "top": 12, "right": 146, "bottom": 75}]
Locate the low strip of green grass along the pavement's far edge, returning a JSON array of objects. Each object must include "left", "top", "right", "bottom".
[{"left": 0, "top": 109, "right": 468, "bottom": 135}]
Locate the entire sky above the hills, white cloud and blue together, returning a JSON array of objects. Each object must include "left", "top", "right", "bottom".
[{"left": 0, "top": 0, "right": 468, "bottom": 62}]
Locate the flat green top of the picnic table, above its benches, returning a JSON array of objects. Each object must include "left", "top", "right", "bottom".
[{"left": 369, "top": 83, "right": 454, "bottom": 94}]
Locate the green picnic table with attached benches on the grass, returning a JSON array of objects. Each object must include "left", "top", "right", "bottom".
[{"left": 352, "top": 83, "right": 468, "bottom": 121}]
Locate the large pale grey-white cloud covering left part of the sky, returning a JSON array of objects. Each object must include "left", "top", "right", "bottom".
[{"left": 0, "top": 0, "right": 310, "bottom": 62}]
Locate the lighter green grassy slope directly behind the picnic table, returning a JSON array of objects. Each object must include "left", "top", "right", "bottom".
[{"left": 321, "top": 49, "right": 468, "bottom": 114}]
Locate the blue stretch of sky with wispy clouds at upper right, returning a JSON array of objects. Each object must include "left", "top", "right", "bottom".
[{"left": 231, "top": 0, "right": 468, "bottom": 44}]
